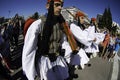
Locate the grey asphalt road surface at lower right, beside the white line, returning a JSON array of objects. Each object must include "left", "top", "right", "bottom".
[{"left": 74, "top": 57, "right": 113, "bottom": 80}]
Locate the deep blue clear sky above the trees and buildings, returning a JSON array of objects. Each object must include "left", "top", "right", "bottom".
[{"left": 0, "top": 0, "right": 120, "bottom": 24}]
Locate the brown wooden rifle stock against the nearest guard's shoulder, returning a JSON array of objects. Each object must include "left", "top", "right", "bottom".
[{"left": 62, "top": 22, "right": 78, "bottom": 51}]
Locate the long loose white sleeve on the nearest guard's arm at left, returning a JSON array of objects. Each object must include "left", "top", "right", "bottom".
[{"left": 22, "top": 19, "right": 41, "bottom": 80}]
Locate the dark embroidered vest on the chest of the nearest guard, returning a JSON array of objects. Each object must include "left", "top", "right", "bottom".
[{"left": 37, "top": 16, "right": 63, "bottom": 56}]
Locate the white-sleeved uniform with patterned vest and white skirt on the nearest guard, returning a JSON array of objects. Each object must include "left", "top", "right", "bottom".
[{"left": 22, "top": 16, "right": 69, "bottom": 80}]
